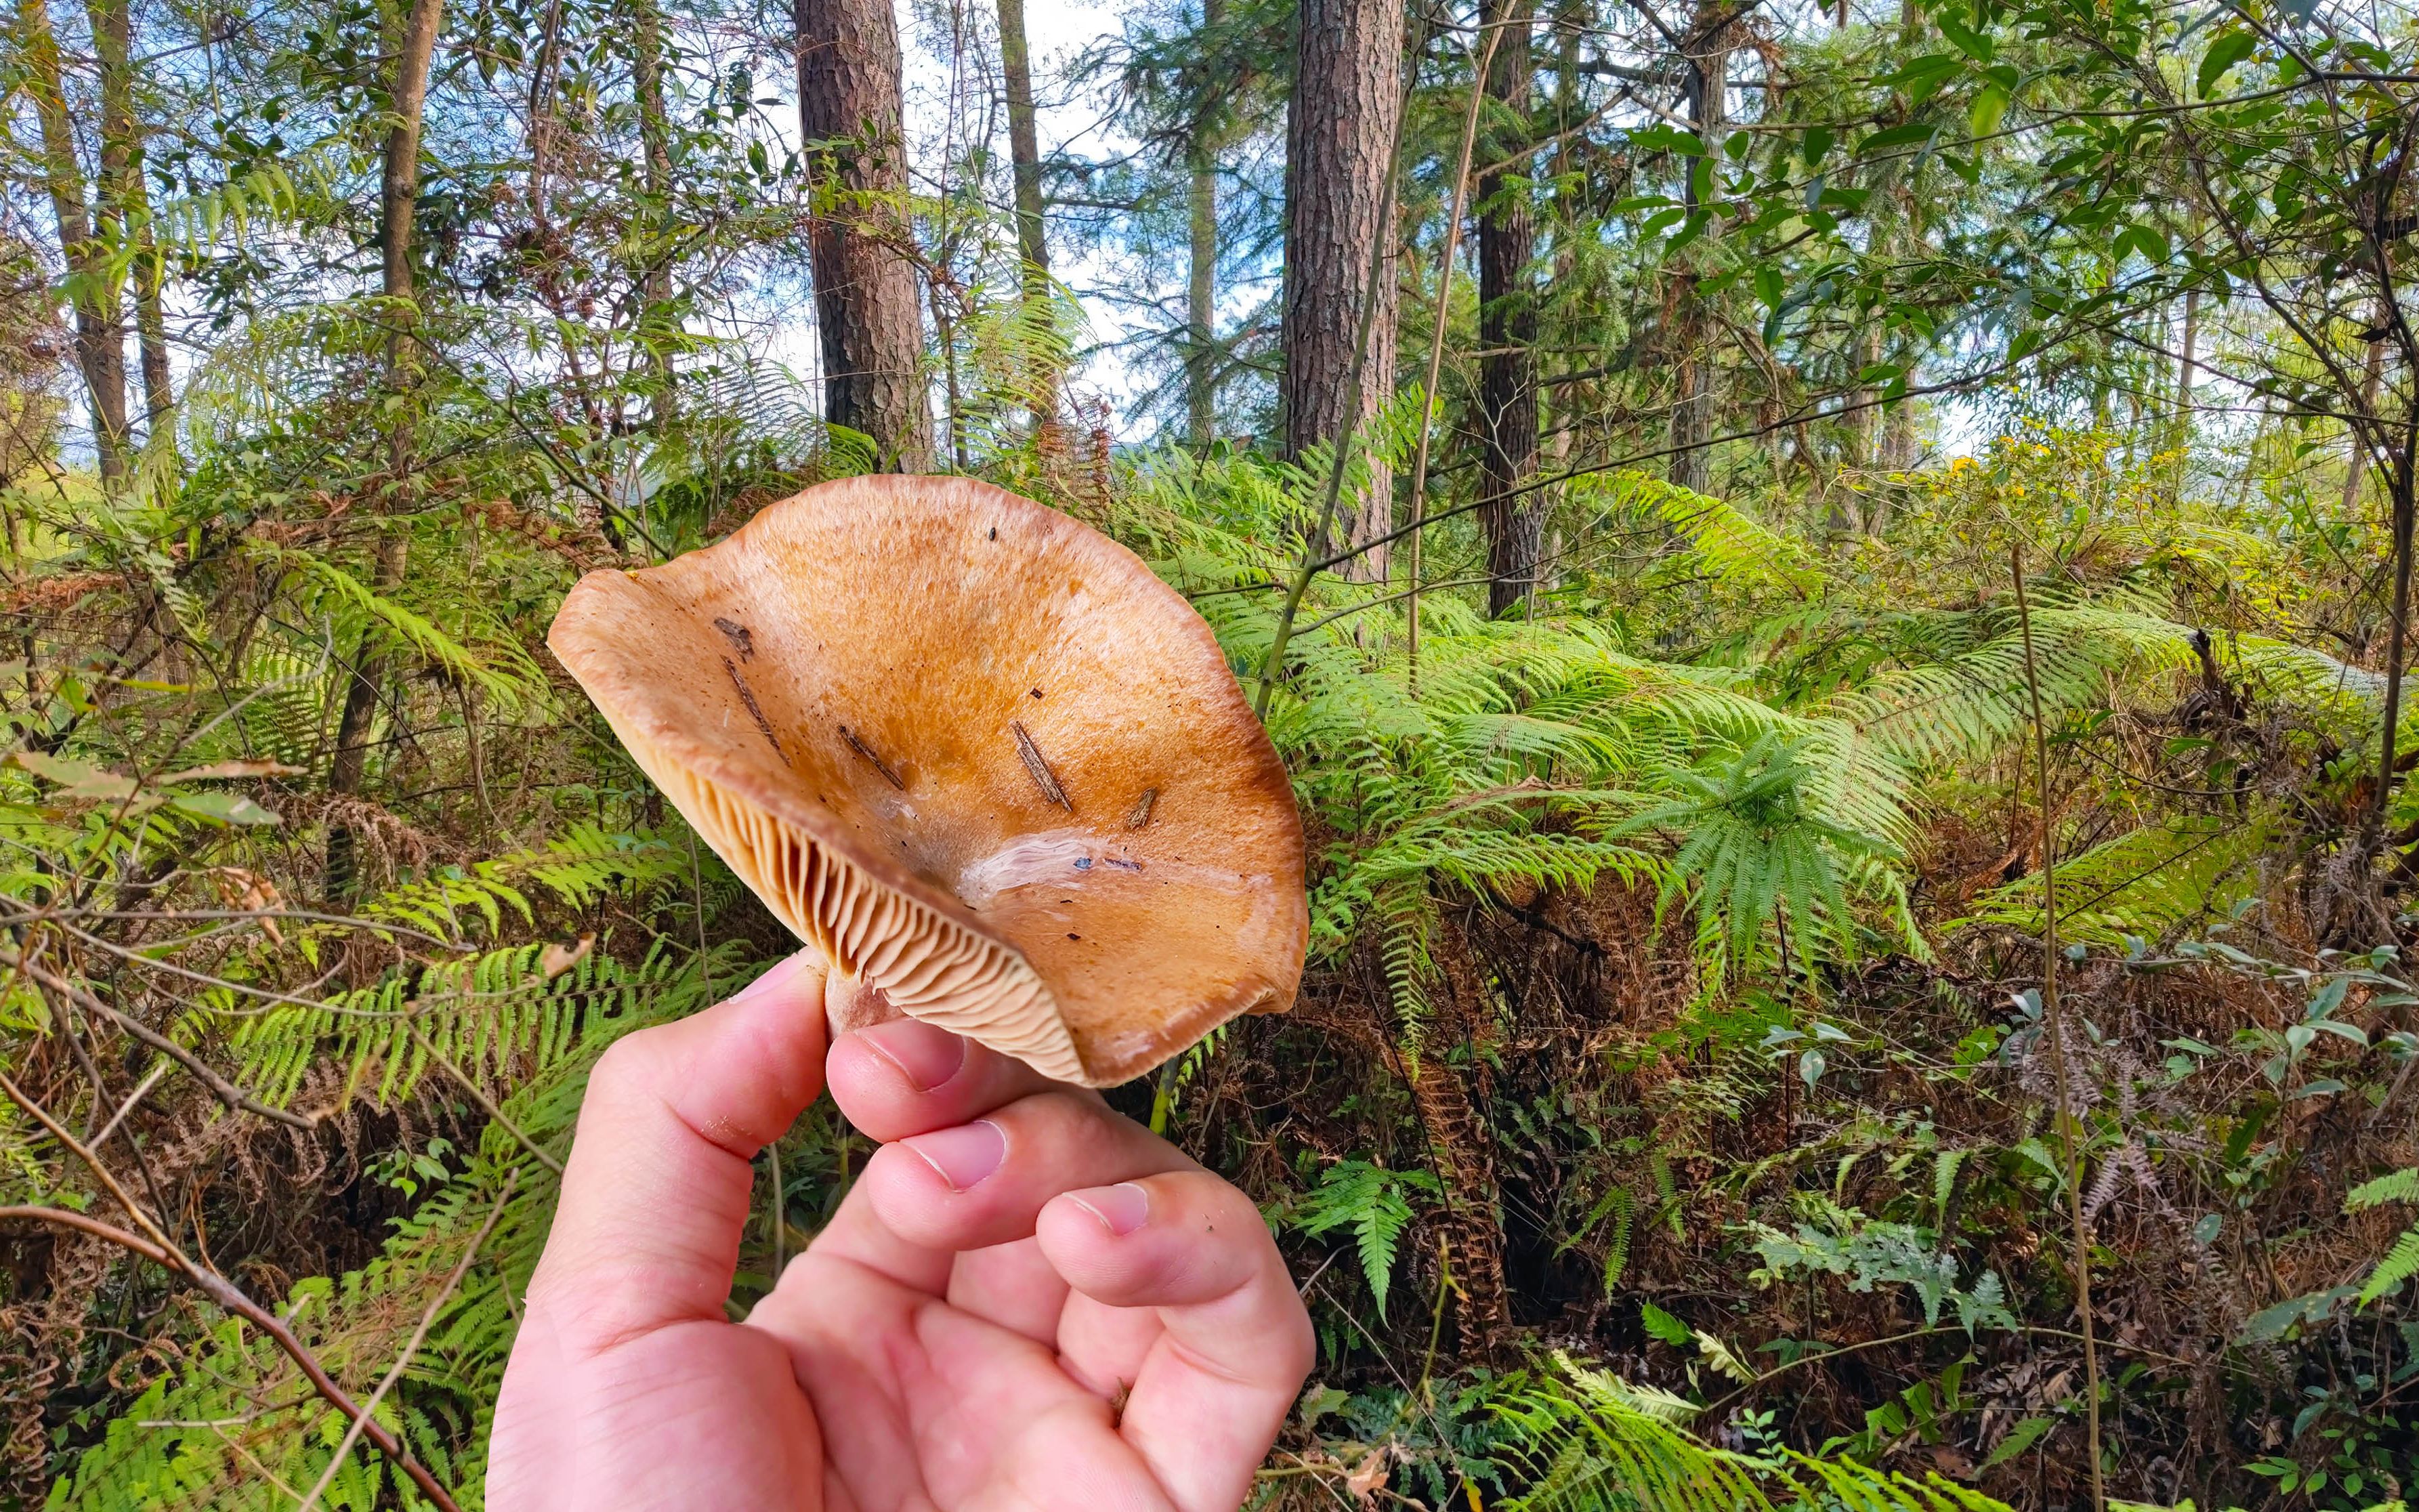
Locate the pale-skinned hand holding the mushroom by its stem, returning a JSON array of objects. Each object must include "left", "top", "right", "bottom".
[{"left": 486, "top": 956, "right": 1311, "bottom": 1512}]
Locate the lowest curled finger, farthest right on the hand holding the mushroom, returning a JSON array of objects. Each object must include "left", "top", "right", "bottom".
[{"left": 1038, "top": 1171, "right": 1313, "bottom": 1512}]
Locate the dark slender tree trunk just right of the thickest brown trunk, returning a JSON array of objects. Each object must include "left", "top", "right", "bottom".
[{"left": 1478, "top": 0, "right": 1546, "bottom": 614}]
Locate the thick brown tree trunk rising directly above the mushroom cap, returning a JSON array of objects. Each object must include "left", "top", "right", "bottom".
[{"left": 791, "top": 0, "right": 931, "bottom": 471}]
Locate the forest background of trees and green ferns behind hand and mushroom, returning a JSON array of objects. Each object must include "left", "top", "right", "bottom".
[{"left": 0, "top": 0, "right": 2419, "bottom": 1512}]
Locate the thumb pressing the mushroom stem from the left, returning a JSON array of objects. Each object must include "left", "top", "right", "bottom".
[{"left": 530, "top": 953, "right": 825, "bottom": 1352}]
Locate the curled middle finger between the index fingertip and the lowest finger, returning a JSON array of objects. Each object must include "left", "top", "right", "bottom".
[{"left": 859, "top": 1091, "right": 1193, "bottom": 1253}]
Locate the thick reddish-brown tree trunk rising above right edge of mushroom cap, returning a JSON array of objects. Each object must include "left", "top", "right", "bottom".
[{"left": 1277, "top": 0, "right": 1403, "bottom": 583}]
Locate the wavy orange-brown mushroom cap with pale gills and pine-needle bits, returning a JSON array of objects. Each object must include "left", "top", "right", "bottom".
[{"left": 547, "top": 477, "right": 1309, "bottom": 1086}]
